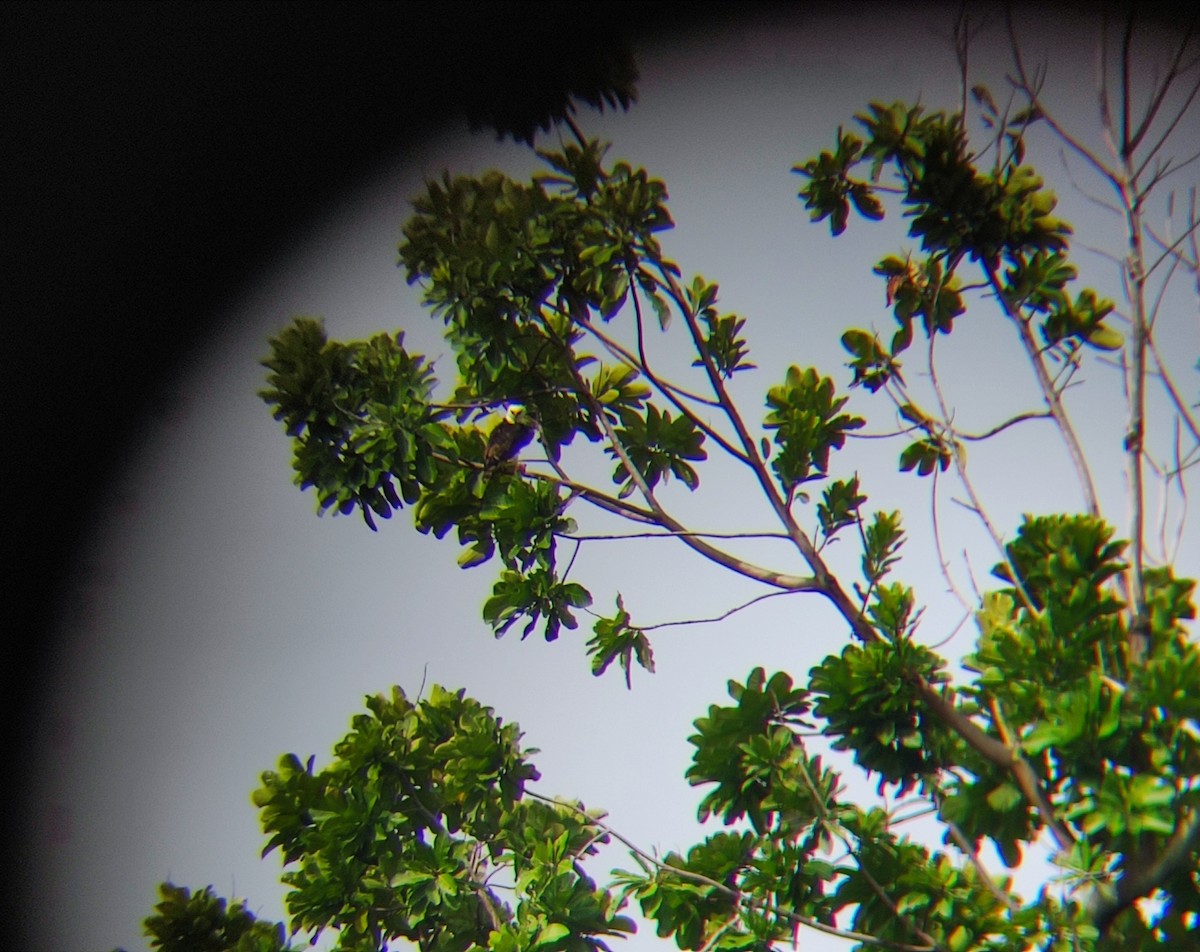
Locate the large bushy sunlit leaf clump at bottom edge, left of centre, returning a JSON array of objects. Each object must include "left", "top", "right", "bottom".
[{"left": 246, "top": 687, "right": 630, "bottom": 952}]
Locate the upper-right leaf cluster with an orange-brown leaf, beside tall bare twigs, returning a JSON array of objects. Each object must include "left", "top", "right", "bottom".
[{"left": 793, "top": 97, "right": 1123, "bottom": 475}]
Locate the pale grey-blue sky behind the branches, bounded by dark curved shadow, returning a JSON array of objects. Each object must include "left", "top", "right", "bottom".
[{"left": 23, "top": 5, "right": 1200, "bottom": 952}]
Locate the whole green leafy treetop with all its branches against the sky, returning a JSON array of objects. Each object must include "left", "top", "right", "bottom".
[{"left": 131, "top": 9, "right": 1200, "bottom": 952}]
